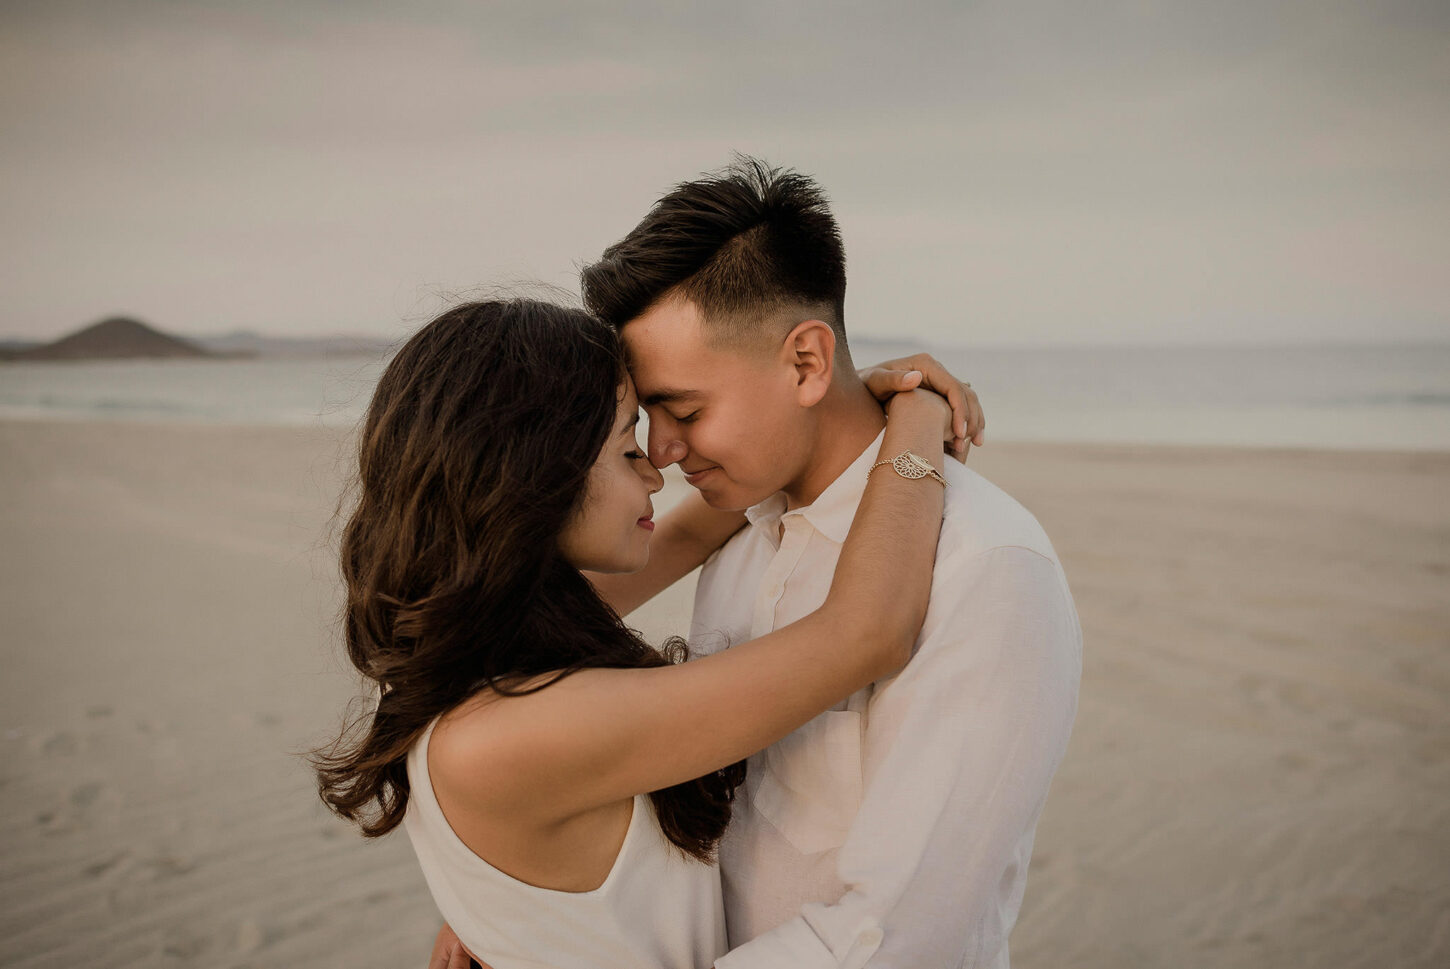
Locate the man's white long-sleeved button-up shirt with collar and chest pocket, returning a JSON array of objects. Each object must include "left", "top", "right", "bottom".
[{"left": 690, "top": 437, "right": 1082, "bottom": 969}]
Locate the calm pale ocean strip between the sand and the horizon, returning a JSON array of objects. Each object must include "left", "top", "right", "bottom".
[{"left": 0, "top": 341, "right": 1450, "bottom": 451}]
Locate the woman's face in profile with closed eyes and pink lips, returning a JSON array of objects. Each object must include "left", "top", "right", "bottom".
[{"left": 558, "top": 377, "right": 664, "bottom": 572}]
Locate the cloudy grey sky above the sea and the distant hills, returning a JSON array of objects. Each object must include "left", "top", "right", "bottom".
[{"left": 0, "top": 0, "right": 1450, "bottom": 344}]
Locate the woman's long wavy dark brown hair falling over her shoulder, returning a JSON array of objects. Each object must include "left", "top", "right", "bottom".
[{"left": 313, "top": 299, "right": 744, "bottom": 859}]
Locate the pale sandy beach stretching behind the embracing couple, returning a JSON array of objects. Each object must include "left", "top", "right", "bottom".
[{"left": 0, "top": 422, "right": 1450, "bottom": 969}]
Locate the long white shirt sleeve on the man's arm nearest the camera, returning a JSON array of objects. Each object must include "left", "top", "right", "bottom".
[{"left": 716, "top": 547, "right": 1082, "bottom": 969}]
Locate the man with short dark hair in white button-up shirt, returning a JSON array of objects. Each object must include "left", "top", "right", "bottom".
[{"left": 429, "top": 160, "right": 1082, "bottom": 969}]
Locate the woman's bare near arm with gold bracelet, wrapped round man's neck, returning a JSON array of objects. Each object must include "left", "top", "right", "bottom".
[{"left": 434, "top": 392, "right": 951, "bottom": 822}]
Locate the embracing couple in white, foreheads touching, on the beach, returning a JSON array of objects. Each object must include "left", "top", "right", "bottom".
[{"left": 318, "top": 160, "right": 1082, "bottom": 969}]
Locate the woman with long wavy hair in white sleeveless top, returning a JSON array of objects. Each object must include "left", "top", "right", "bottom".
[{"left": 318, "top": 300, "right": 974, "bottom": 969}]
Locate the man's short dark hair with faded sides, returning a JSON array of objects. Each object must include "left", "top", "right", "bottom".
[{"left": 581, "top": 155, "right": 845, "bottom": 352}]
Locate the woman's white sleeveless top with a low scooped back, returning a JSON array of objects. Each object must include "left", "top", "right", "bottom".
[{"left": 403, "top": 719, "right": 725, "bottom": 969}]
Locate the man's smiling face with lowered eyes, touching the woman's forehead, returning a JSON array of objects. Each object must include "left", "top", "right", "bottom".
[{"left": 621, "top": 297, "right": 808, "bottom": 509}]
